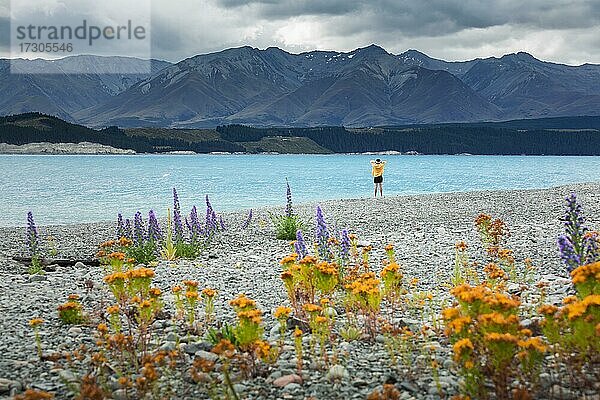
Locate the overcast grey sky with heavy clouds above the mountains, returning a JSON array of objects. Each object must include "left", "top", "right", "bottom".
[{"left": 0, "top": 0, "right": 600, "bottom": 65}]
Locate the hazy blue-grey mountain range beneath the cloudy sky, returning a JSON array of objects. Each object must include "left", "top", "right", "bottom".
[{"left": 0, "top": 45, "right": 600, "bottom": 128}]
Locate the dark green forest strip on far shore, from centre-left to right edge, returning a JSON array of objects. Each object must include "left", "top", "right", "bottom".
[{"left": 217, "top": 117, "right": 600, "bottom": 155}]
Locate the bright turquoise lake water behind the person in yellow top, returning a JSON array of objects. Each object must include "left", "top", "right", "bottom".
[{"left": 0, "top": 155, "right": 600, "bottom": 226}]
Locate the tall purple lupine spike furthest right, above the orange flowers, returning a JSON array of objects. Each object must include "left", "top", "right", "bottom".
[{"left": 557, "top": 193, "right": 588, "bottom": 272}]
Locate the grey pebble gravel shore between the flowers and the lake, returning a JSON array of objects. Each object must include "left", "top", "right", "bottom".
[{"left": 0, "top": 182, "right": 600, "bottom": 399}]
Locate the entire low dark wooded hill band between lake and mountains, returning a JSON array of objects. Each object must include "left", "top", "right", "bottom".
[{"left": 0, "top": 113, "right": 600, "bottom": 155}]
